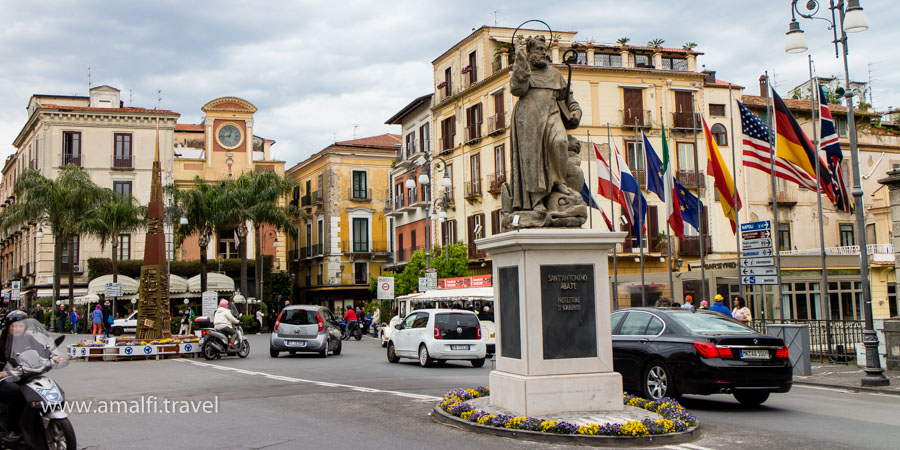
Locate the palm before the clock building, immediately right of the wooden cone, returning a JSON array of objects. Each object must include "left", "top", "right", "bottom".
[{"left": 166, "top": 176, "right": 225, "bottom": 292}]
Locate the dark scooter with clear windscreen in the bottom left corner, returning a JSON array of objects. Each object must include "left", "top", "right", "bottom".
[{"left": 0, "top": 311, "right": 77, "bottom": 449}]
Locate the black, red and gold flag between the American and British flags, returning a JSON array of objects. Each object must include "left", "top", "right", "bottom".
[{"left": 772, "top": 89, "right": 835, "bottom": 203}]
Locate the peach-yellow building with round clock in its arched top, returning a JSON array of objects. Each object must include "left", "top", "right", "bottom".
[{"left": 173, "top": 97, "right": 288, "bottom": 278}]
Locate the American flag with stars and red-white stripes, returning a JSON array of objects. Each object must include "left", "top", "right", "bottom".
[{"left": 738, "top": 102, "right": 816, "bottom": 191}]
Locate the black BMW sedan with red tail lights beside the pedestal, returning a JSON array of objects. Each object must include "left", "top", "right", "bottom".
[{"left": 611, "top": 308, "right": 793, "bottom": 406}]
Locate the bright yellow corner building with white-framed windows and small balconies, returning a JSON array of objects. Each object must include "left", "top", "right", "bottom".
[{"left": 287, "top": 134, "right": 400, "bottom": 313}]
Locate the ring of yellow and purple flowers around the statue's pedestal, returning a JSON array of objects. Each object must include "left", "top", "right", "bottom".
[{"left": 439, "top": 386, "right": 697, "bottom": 437}]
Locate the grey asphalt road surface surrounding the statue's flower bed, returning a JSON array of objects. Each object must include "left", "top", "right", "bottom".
[{"left": 52, "top": 335, "right": 900, "bottom": 449}]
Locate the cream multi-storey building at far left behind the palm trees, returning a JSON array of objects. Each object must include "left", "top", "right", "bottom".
[{"left": 0, "top": 86, "right": 179, "bottom": 303}]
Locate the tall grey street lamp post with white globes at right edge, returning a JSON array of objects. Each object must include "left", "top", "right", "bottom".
[{"left": 784, "top": 0, "right": 890, "bottom": 386}]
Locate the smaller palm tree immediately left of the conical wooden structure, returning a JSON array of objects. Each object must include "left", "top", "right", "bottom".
[{"left": 86, "top": 189, "right": 147, "bottom": 283}]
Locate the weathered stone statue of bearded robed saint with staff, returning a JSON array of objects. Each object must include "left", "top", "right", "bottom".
[{"left": 502, "top": 37, "right": 587, "bottom": 229}]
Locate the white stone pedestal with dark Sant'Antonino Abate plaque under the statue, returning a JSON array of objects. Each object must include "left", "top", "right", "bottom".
[{"left": 476, "top": 229, "right": 625, "bottom": 416}]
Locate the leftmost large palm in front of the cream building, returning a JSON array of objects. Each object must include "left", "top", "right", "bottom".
[{"left": 0, "top": 164, "right": 103, "bottom": 308}]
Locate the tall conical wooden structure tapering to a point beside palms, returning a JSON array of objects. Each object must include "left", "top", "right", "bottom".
[{"left": 137, "top": 121, "right": 172, "bottom": 340}]
